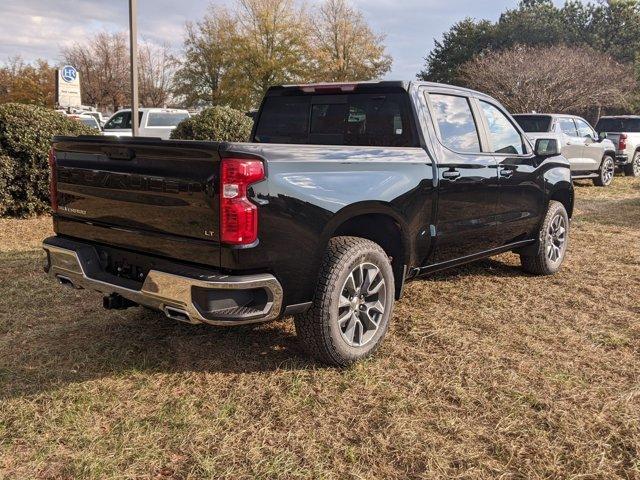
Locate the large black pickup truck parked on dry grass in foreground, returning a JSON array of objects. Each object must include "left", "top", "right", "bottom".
[{"left": 43, "top": 81, "right": 573, "bottom": 365}]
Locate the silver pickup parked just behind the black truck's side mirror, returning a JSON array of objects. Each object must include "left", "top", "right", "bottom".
[{"left": 513, "top": 113, "right": 616, "bottom": 187}]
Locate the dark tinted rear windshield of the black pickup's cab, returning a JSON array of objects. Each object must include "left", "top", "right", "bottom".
[{"left": 254, "top": 93, "right": 419, "bottom": 147}]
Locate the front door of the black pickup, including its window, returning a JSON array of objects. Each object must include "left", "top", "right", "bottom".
[{"left": 476, "top": 99, "right": 544, "bottom": 246}]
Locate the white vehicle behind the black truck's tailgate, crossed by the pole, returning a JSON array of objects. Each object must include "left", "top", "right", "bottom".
[{"left": 104, "top": 108, "right": 189, "bottom": 140}]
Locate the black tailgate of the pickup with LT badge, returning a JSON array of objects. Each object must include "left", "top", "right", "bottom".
[{"left": 54, "top": 137, "right": 220, "bottom": 265}]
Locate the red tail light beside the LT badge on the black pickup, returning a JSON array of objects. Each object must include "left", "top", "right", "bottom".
[{"left": 220, "top": 158, "right": 264, "bottom": 245}]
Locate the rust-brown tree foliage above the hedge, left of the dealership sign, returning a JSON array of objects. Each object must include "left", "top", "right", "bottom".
[{"left": 0, "top": 56, "right": 55, "bottom": 107}]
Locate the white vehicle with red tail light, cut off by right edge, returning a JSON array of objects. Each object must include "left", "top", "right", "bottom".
[{"left": 596, "top": 115, "right": 640, "bottom": 177}]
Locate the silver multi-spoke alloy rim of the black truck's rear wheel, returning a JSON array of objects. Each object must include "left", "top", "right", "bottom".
[{"left": 338, "top": 262, "right": 387, "bottom": 347}]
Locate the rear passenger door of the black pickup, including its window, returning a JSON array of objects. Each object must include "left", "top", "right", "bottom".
[{"left": 427, "top": 91, "right": 498, "bottom": 263}]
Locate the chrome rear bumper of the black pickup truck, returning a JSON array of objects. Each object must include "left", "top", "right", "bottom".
[{"left": 42, "top": 237, "right": 283, "bottom": 325}]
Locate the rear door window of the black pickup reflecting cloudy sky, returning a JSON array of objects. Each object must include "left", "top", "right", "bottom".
[{"left": 429, "top": 93, "right": 480, "bottom": 153}]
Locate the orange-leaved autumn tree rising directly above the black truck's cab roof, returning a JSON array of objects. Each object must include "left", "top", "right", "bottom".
[{"left": 312, "top": 0, "right": 392, "bottom": 82}]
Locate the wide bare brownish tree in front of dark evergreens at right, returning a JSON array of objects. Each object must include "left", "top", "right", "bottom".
[{"left": 460, "top": 45, "right": 636, "bottom": 113}]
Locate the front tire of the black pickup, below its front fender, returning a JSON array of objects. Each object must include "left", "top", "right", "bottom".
[{"left": 520, "top": 200, "right": 569, "bottom": 275}]
